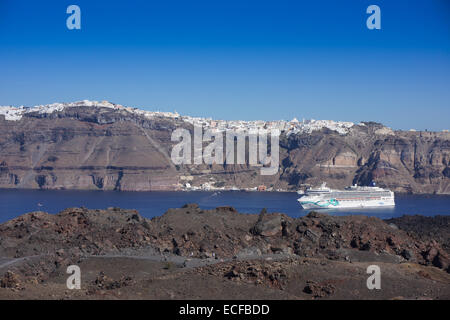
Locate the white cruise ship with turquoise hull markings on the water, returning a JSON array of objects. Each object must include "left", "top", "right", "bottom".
[{"left": 297, "top": 183, "right": 395, "bottom": 209}]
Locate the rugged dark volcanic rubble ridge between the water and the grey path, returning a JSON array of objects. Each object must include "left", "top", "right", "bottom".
[{"left": 0, "top": 204, "right": 449, "bottom": 282}]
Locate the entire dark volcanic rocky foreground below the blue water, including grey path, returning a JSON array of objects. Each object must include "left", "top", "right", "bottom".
[{"left": 0, "top": 204, "right": 450, "bottom": 299}]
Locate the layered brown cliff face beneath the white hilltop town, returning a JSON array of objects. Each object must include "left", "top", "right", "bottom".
[{"left": 0, "top": 105, "right": 450, "bottom": 194}]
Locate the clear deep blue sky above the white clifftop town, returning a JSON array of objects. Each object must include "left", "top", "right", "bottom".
[{"left": 0, "top": 0, "right": 450, "bottom": 130}]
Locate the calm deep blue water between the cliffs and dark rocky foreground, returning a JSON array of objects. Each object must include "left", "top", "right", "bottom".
[{"left": 0, "top": 190, "right": 450, "bottom": 222}]
